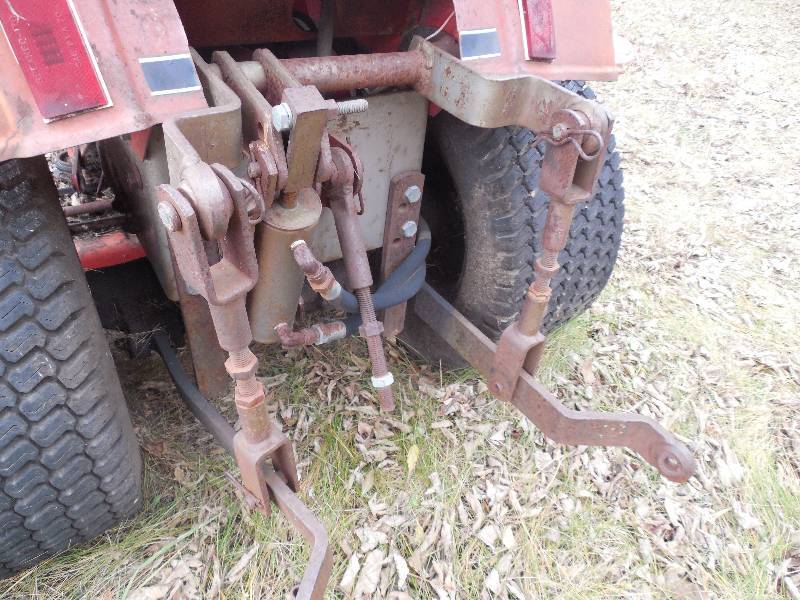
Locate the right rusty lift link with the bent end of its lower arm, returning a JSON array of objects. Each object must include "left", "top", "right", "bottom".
[{"left": 482, "top": 110, "right": 695, "bottom": 482}]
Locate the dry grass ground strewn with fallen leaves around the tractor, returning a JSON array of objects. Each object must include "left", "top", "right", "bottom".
[{"left": 0, "top": 0, "right": 800, "bottom": 599}]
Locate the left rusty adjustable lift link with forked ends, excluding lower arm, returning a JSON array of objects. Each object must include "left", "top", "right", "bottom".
[{"left": 158, "top": 164, "right": 297, "bottom": 514}]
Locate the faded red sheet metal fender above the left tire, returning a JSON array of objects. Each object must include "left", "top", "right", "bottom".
[{"left": 0, "top": 0, "right": 207, "bottom": 161}]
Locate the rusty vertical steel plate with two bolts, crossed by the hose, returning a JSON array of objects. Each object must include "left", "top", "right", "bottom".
[{"left": 381, "top": 171, "right": 425, "bottom": 337}]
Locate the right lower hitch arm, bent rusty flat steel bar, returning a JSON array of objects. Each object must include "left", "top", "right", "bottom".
[{"left": 413, "top": 284, "right": 695, "bottom": 482}]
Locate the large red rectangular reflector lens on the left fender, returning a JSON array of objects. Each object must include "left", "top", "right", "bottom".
[{"left": 0, "top": 0, "right": 109, "bottom": 119}]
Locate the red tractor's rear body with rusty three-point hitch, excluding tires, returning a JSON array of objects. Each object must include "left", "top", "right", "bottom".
[{"left": 0, "top": 0, "right": 694, "bottom": 598}]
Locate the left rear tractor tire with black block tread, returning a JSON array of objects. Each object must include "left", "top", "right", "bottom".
[{"left": 0, "top": 157, "right": 141, "bottom": 578}]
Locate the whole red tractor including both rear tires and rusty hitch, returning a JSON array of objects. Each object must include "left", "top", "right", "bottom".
[{"left": 0, "top": 0, "right": 694, "bottom": 598}]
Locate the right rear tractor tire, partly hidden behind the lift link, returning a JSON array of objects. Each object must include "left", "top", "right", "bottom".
[{"left": 404, "top": 81, "right": 625, "bottom": 366}]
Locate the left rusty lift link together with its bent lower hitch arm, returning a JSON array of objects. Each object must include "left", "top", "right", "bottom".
[{"left": 155, "top": 163, "right": 332, "bottom": 600}]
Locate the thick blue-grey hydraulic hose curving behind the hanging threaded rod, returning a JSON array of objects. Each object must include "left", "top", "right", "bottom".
[{"left": 329, "top": 221, "right": 431, "bottom": 313}]
